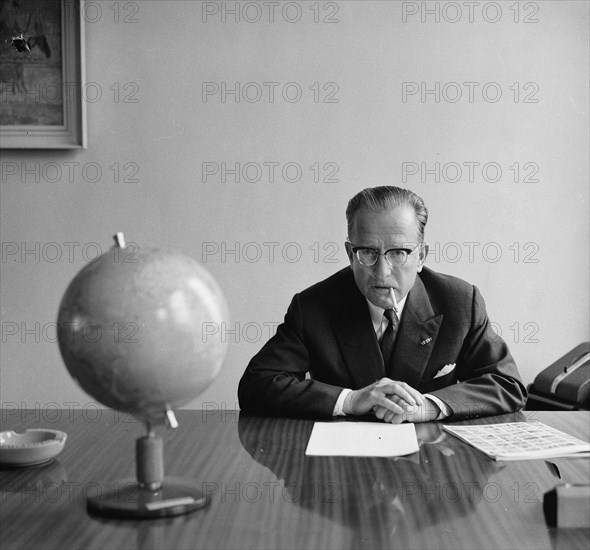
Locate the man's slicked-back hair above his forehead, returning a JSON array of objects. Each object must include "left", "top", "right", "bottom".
[{"left": 346, "top": 185, "right": 428, "bottom": 242}]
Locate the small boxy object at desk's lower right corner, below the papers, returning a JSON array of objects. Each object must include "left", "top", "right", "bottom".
[{"left": 543, "top": 483, "right": 590, "bottom": 527}]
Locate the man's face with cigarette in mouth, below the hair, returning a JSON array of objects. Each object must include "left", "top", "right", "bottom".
[{"left": 346, "top": 206, "right": 425, "bottom": 309}]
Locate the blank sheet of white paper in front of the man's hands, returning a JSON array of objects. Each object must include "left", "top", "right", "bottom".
[{"left": 305, "top": 422, "right": 419, "bottom": 456}]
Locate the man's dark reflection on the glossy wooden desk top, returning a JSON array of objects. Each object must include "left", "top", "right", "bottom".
[{"left": 238, "top": 414, "right": 502, "bottom": 548}]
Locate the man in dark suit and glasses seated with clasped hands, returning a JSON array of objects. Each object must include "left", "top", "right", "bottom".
[{"left": 238, "top": 186, "right": 526, "bottom": 423}]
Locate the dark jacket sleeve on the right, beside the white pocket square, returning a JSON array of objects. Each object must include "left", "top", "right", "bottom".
[{"left": 431, "top": 287, "right": 526, "bottom": 420}]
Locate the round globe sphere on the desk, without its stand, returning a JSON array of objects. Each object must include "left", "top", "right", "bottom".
[{"left": 57, "top": 247, "right": 228, "bottom": 423}]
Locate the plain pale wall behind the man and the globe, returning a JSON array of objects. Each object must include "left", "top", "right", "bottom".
[{"left": 1, "top": 1, "right": 589, "bottom": 409}]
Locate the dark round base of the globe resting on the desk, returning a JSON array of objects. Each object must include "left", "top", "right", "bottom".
[{"left": 86, "top": 477, "right": 210, "bottom": 519}]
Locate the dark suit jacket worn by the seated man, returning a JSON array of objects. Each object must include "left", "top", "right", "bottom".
[{"left": 238, "top": 267, "right": 526, "bottom": 419}]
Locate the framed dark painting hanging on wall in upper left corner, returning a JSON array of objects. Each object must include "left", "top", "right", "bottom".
[{"left": 0, "top": 0, "right": 86, "bottom": 149}]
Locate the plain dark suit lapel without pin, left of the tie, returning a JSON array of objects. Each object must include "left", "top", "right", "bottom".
[{"left": 332, "top": 271, "right": 385, "bottom": 389}]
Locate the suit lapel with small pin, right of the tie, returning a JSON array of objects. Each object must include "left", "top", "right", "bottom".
[{"left": 387, "top": 277, "right": 443, "bottom": 388}]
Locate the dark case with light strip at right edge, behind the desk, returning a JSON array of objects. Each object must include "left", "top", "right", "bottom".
[{"left": 526, "top": 342, "right": 590, "bottom": 411}]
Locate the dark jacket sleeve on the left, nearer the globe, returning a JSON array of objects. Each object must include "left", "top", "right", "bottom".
[{"left": 238, "top": 294, "right": 343, "bottom": 418}]
